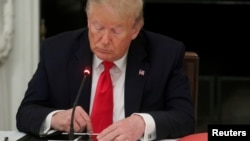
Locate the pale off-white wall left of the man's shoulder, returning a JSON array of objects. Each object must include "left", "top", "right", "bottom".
[{"left": 0, "top": 0, "right": 40, "bottom": 130}]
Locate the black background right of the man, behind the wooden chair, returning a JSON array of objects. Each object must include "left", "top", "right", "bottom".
[{"left": 145, "top": 1, "right": 250, "bottom": 131}]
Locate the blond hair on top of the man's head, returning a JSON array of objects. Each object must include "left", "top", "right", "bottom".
[{"left": 86, "top": 0, "right": 144, "bottom": 25}]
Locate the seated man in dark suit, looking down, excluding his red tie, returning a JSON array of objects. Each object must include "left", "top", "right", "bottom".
[{"left": 16, "top": 0, "right": 195, "bottom": 141}]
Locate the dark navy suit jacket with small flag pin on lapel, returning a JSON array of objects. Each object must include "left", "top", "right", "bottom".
[{"left": 16, "top": 28, "right": 195, "bottom": 139}]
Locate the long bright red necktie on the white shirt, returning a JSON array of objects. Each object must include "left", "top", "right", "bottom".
[{"left": 91, "top": 61, "right": 114, "bottom": 133}]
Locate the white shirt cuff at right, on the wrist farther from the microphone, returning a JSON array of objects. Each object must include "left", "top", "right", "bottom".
[{"left": 134, "top": 113, "right": 156, "bottom": 141}]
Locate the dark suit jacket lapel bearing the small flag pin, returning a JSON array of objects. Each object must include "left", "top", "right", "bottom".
[{"left": 125, "top": 33, "right": 149, "bottom": 117}]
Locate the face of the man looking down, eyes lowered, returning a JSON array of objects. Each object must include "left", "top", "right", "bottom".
[{"left": 88, "top": 5, "right": 140, "bottom": 61}]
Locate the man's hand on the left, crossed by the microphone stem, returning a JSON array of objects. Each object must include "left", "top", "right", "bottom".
[{"left": 51, "top": 106, "right": 93, "bottom": 133}]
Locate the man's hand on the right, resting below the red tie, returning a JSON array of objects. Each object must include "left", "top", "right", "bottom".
[{"left": 97, "top": 115, "right": 145, "bottom": 141}]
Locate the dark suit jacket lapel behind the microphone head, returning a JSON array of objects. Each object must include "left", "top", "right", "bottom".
[{"left": 69, "top": 31, "right": 93, "bottom": 112}]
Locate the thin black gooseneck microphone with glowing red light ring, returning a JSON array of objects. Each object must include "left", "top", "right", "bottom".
[{"left": 69, "top": 68, "right": 90, "bottom": 140}]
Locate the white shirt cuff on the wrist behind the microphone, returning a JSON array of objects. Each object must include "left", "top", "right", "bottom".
[{"left": 39, "top": 110, "right": 62, "bottom": 137}]
